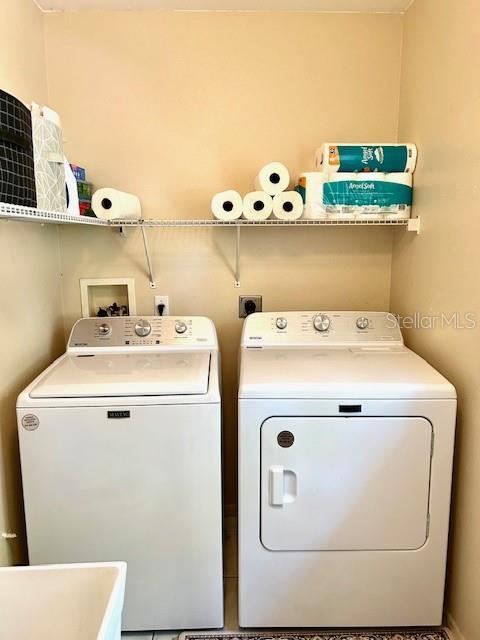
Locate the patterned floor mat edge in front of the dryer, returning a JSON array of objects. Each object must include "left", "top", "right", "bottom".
[{"left": 180, "top": 629, "right": 449, "bottom": 640}]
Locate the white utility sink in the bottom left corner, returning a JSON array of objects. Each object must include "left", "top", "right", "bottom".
[{"left": 0, "top": 562, "right": 127, "bottom": 640}]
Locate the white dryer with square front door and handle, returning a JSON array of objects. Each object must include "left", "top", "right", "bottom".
[{"left": 239, "top": 311, "right": 456, "bottom": 627}]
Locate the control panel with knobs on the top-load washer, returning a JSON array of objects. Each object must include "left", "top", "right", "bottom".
[{"left": 68, "top": 316, "right": 217, "bottom": 349}]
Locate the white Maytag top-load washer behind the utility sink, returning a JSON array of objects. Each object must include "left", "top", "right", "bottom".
[{"left": 17, "top": 317, "right": 223, "bottom": 630}]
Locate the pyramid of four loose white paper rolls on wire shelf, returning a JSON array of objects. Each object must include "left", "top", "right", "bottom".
[{"left": 211, "top": 162, "right": 303, "bottom": 222}]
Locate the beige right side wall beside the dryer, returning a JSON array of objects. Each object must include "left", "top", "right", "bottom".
[{"left": 391, "top": 0, "right": 480, "bottom": 640}]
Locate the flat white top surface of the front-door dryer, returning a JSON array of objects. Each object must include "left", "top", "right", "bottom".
[{"left": 239, "top": 345, "right": 456, "bottom": 399}]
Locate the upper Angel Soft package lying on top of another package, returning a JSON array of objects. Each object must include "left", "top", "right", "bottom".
[{"left": 315, "top": 142, "right": 417, "bottom": 173}]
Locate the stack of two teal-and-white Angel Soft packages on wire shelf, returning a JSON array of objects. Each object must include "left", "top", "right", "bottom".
[{"left": 296, "top": 143, "right": 417, "bottom": 219}]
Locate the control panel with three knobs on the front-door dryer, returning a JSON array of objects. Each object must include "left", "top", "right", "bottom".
[{"left": 242, "top": 311, "right": 403, "bottom": 347}]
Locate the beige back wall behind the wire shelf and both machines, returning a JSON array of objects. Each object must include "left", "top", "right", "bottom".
[{"left": 46, "top": 12, "right": 402, "bottom": 504}]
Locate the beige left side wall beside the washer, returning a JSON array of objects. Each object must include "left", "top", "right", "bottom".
[{"left": 0, "top": 0, "right": 63, "bottom": 565}]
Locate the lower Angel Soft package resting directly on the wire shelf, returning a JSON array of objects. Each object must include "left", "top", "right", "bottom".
[{"left": 296, "top": 172, "right": 412, "bottom": 219}]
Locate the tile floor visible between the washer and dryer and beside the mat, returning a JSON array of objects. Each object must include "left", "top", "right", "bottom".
[{"left": 122, "top": 516, "right": 238, "bottom": 640}]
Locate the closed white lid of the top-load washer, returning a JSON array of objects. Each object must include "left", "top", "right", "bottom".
[{"left": 30, "top": 351, "right": 210, "bottom": 398}]
